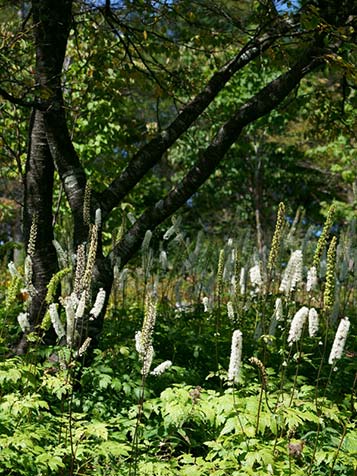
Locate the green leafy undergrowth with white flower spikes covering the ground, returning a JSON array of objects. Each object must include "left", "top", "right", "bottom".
[{"left": 0, "top": 205, "right": 357, "bottom": 476}]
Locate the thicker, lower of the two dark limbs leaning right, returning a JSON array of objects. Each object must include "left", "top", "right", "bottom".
[{"left": 114, "top": 43, "right": 323, "bottom": 266}]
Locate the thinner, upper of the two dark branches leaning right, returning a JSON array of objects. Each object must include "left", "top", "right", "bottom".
[{"left": 99, "top": 20, "right": 291, "bottom": 218}]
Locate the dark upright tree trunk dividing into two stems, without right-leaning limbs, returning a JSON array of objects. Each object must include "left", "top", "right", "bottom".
[{"left": 18, "top": 0, "right": 113, "bottom": 352}]
